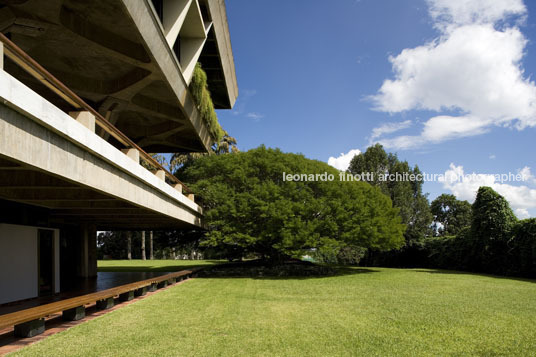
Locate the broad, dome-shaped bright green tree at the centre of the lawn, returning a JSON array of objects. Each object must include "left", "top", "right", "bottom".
[{"left": 178, "top": 146, "right": 404, "bottom": 260}]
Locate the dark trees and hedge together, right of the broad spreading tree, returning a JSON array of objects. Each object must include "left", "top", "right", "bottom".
[{"left": 348, "top": 144, "right": 536, "bottom": 277}]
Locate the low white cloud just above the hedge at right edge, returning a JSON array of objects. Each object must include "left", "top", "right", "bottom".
[{"left": 442, "top": 163, "right": 536, "bottom": 218}]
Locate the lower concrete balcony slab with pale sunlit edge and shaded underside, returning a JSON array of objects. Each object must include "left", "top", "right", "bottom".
[{"left": 0, "top": 71, "right": 202, "bottom": 230}]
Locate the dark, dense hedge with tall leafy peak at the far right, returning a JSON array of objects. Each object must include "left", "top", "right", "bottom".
[{"left": 413, "top": 187, "right": 536, "bottom": 278}]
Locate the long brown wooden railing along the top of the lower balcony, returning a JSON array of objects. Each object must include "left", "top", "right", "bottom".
[{"left": 0, "top": 32, "right": 192, "bottom": 193}]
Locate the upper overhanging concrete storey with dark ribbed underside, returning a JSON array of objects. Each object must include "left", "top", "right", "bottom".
[{"left": 0, "top": 0, "right": 237, "bottom": 152}]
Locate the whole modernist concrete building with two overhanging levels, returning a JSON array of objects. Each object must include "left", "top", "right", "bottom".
[{"left": 0, "top": 0, "right": 238, "bottom": 304}]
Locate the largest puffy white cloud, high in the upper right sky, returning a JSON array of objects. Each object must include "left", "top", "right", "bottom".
[{"left": 371, "top": 0, "right": 536, "bottom": 149}]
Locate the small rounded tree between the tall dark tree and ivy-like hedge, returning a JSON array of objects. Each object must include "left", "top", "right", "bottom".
[{"left": 430, "top": 194, "right": 472, "bottom": 236}]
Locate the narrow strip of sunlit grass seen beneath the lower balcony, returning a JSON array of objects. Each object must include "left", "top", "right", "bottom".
[{"left": 97, "top": 259, "right": 221, "bottom": 272}]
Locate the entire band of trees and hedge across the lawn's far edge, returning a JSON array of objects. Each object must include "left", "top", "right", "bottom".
[{"left": 99, "top": 143, "right": 536, "bottom": 277}]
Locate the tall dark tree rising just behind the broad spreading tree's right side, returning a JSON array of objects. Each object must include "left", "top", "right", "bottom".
[{"left": 348, "top": 144, "right": 433, "bottom": 245}]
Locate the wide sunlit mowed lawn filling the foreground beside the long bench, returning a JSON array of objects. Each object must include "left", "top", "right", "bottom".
[{"left": 11, "top": 268, "right": 536, "bottom": 356}]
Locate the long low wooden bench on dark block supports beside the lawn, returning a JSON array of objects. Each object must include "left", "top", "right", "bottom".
[{"left": 0, "top": 268, "right": 201, "bottom": 337}]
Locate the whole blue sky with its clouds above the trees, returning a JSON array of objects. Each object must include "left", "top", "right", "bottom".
[{"left": 218, "top": 0, "right": 536, "bottom": 218}]
